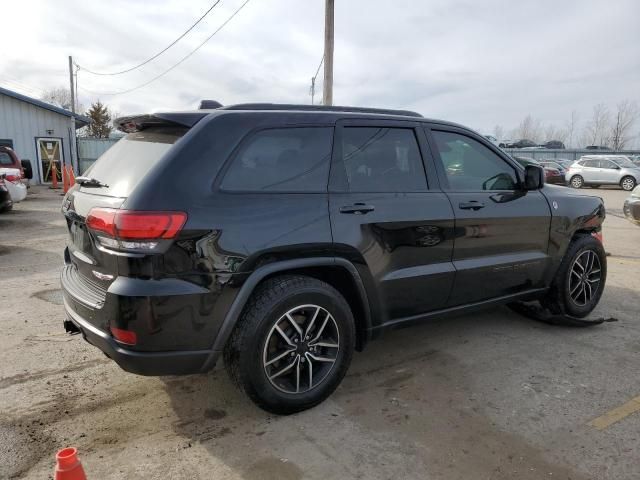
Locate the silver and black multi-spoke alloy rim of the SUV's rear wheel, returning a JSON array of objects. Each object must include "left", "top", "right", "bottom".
[{"left": 262, "top": 305, "right": 340, "bottom": 394}]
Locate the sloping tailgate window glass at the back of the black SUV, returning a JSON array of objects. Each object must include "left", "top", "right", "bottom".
[{"left": 83, "top": 128, "right": 188, "bottom": 197}]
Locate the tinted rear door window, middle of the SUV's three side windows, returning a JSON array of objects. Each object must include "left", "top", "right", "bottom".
[{"left": 342, "top": 127, "right": 427, "bottom": 193}]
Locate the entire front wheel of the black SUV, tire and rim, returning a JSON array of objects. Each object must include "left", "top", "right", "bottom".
[{"left": 541, "top": 234, "right": 607, "bottom": 318}]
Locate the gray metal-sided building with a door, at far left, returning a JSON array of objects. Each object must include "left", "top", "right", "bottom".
[{"left": 0, "top": 87, "right": 89, "bottom": 183}]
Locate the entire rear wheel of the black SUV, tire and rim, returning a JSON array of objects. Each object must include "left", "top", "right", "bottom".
[{"left": 224, "top": 275, "right": 355, "bottom": 414}]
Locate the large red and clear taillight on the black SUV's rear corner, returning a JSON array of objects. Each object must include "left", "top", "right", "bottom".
[{"left": 86, "top": 208, "right": 187, "bottom": 251}]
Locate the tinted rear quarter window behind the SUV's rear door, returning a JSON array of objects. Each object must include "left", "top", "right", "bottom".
[{"left": 220, "top": 127, "right": 333, "bottom": 192}]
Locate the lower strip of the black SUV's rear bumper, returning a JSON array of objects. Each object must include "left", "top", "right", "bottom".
[{"left": 64, "top": 298, "right": 212, "bottom": 375}]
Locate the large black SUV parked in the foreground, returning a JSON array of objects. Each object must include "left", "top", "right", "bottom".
[{"left": 61, "top": 104, "right": 606, "bottom": 413}]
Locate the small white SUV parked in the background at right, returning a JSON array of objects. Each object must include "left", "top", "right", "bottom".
[{"left": 565, "top": 155, "right": 640, "bottom": 191}]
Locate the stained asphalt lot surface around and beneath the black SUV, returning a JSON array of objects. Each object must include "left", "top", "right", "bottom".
[{"left": 0, "top": 187, "right": 640, "bottom": 480}]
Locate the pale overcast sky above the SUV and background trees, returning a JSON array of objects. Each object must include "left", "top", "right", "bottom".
[{"left": 0, "top": 0, "right": 640, "bottom": 133}]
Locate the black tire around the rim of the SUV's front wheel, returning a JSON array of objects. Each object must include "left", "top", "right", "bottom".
[{"left": 541, "top": 234, "right": 607, "bottom": 318}]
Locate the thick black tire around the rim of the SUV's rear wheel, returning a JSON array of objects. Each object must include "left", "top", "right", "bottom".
[{"left": 224, "top": 275, "right": 355, "bottom": 415}]
